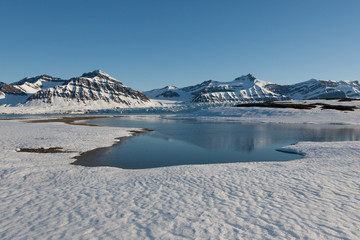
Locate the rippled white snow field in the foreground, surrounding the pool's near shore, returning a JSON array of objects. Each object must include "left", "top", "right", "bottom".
[{"left": 0, "top": 115, "right": 360, "bottom": 239}]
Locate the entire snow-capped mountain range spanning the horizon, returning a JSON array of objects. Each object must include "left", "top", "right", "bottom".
[{"left": 0, "top": 70, "right": 360, "bottom": 108}]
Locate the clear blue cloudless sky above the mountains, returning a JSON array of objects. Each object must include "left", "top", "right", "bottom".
[{"left": 0, "top": 0, "right": 360, "bottom": 90}]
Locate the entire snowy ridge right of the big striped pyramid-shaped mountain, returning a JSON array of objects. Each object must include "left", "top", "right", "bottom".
[{"left": 145, "top": 74, "right": 360, "bottom": 103}]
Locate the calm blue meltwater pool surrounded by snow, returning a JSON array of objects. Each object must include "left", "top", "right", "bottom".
[{"left": 74, "top": 116, "right": 360, "bottom": 169}]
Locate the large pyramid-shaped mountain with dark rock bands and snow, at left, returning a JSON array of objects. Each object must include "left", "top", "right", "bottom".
[{"left": 26, "top": 70, "right": 150, "bottom": 107}]
